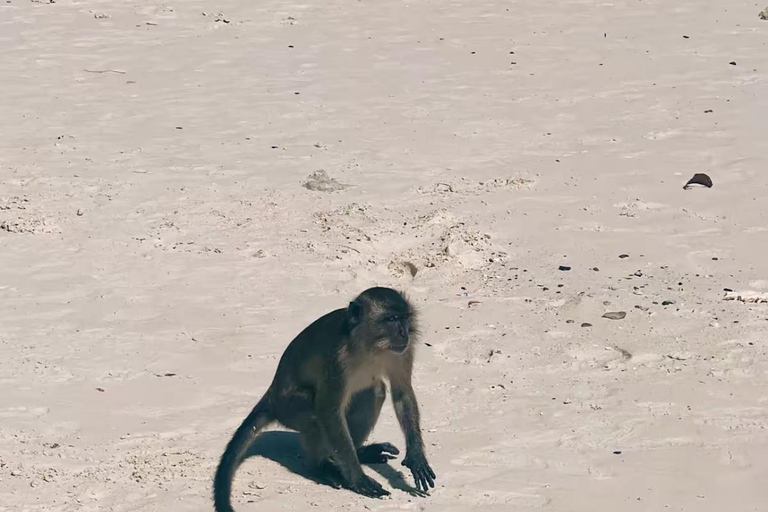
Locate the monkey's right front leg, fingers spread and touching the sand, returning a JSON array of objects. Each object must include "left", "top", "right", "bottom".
[{"left": 392, "top": 383, "right": 435, "bottom": 492}]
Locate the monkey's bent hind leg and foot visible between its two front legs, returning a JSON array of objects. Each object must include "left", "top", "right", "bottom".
[{"left": 347, "top": 381, "right": 400, "bottom": 464}]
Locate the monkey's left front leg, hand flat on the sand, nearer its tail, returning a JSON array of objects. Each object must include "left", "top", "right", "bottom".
[{"left": 315, "top": 392, "right": 390, "bottom": 498}]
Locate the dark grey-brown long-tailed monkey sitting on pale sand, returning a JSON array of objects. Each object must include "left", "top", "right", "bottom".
[{"left": 213, "top": 287, "right": 436, "bottom": 512}]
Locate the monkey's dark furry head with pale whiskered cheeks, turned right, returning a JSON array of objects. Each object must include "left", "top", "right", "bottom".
[{"left": 347, "top": 287, "right": 418, "bottom": 354}]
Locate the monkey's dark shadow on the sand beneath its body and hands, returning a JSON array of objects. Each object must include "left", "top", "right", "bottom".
[{"left": 246, "top": 430, "right": 426, "bottom": 496}]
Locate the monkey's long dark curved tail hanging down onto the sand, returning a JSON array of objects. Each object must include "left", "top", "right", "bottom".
[{"left": 213, "top": 392, "right": 274, "bottom": 512}]
